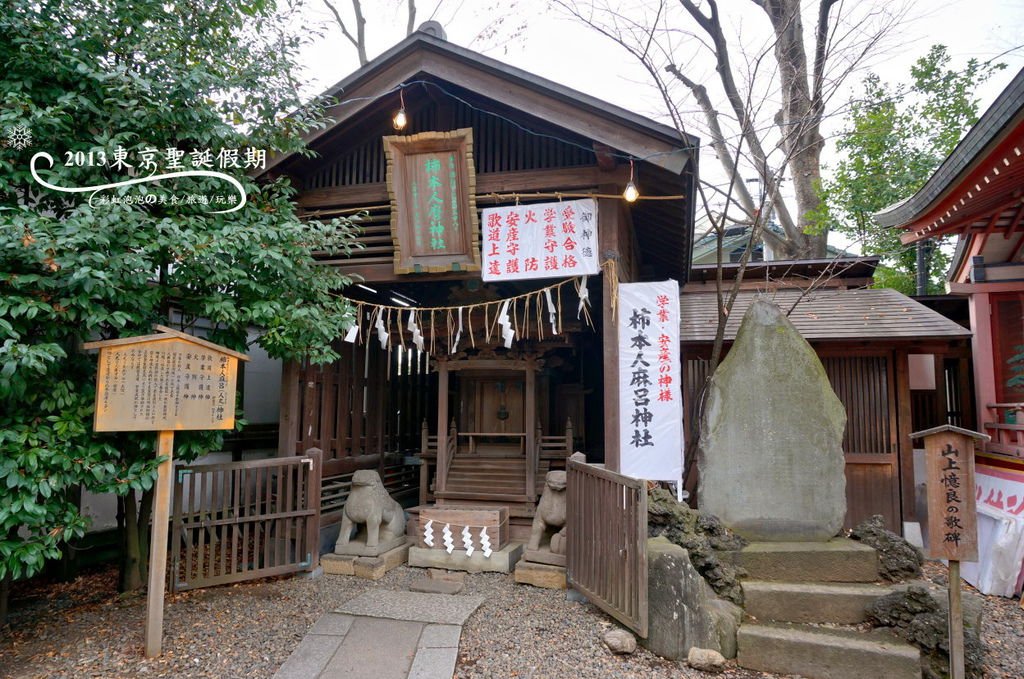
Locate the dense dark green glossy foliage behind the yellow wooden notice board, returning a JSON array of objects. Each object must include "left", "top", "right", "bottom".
[{"left": 0, "top": 0, "right": 360, "bottom": 578}]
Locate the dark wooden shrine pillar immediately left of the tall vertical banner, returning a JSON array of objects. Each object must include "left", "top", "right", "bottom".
[{"left": 597, "top": 191, "right": 624, "bottom": 472}]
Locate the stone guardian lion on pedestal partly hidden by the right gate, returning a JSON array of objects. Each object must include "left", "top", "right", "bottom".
[{"left": 515, "top": 471, "right": 566, "bottom": 590}]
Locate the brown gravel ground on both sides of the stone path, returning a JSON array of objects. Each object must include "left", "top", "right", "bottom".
[{"left": 0, "top": 566, "right": 1024, "bottom": 679}]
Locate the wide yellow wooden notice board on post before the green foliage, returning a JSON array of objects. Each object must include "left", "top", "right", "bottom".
[{"left": 83, "top": 326, "right": 249, "bottom": 657}]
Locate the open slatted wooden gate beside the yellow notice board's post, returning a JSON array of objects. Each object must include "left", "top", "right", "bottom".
[{"left": 171, "top": 449, "right": 322, "bottom": 592}]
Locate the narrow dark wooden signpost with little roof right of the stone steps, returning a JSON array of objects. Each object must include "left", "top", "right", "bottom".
[{"left": 910, "top": 424, "right": 988, "bottom": 679}]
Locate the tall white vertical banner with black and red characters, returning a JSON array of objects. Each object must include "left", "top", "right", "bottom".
[{"left": 617, "top": 280, "right": 683, "bottom": 482}]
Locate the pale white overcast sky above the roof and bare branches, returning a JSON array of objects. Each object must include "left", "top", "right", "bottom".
[{"left": 288, "top": 0, "right": 1024, "bottom": 249}]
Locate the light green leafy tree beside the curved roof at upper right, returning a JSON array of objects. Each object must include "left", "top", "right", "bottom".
[{"left": 816, "top": 45, "right": 1004, "bottom": 294}]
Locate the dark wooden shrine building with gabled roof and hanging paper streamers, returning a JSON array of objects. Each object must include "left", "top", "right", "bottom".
[{"left": 260, "top": 27, "right": 698, "bottom": 534}]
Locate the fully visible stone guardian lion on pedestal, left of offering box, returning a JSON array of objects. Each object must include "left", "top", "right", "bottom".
[{"left": 321, "top": 469, "right": 410, "bottom": 580}]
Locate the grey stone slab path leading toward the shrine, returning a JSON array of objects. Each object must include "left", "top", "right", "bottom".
[{"left": 274, "top": 590, "right": 483, "bottom": 679}]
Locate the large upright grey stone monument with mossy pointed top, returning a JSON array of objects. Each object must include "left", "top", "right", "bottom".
[{"left": 699, "top": 299, "right": 846, "bottom": 542}]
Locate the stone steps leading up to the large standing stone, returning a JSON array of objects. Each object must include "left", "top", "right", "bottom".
[{"left": 733, "top": 540, "right": 921, "bottom": 679}]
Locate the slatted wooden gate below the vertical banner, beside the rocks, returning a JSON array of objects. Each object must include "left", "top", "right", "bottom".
[{"left": 565, "top": 460, "right": 647, "bottom": 638}]
